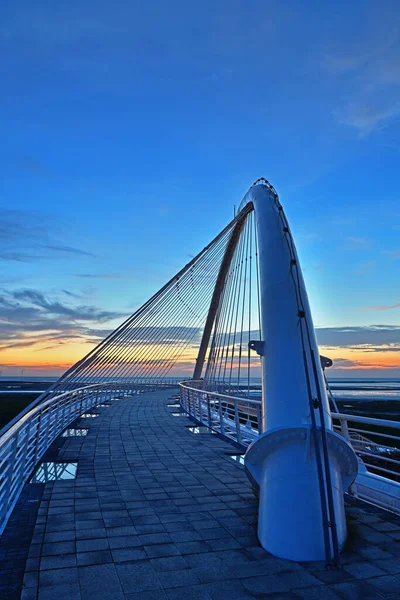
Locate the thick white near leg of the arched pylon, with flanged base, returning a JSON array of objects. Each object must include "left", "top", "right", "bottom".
[{"left": 244, "top": 185, "right": 357, "bottom": 562}]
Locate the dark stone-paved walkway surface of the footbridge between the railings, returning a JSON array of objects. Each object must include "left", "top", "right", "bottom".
[{"left": 0, "top": 391, "right": 400, "bottom": 600}]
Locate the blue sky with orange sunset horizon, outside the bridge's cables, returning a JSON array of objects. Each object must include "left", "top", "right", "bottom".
[{"left": 0, "top": 0, "right": 400, "bottom": 377}]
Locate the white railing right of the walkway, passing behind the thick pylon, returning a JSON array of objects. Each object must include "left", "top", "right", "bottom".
[{"left": 180, "top": 381, "right": 400, "bottom": 514}]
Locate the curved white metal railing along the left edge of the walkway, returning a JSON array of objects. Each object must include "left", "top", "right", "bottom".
[{"left": 0, "top": 381, "right": 176, "bottom": 533}]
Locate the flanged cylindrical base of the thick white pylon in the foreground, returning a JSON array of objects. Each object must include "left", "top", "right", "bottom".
[{"left": 245, "top": 427, "right": 357, "bottom": 561}]
